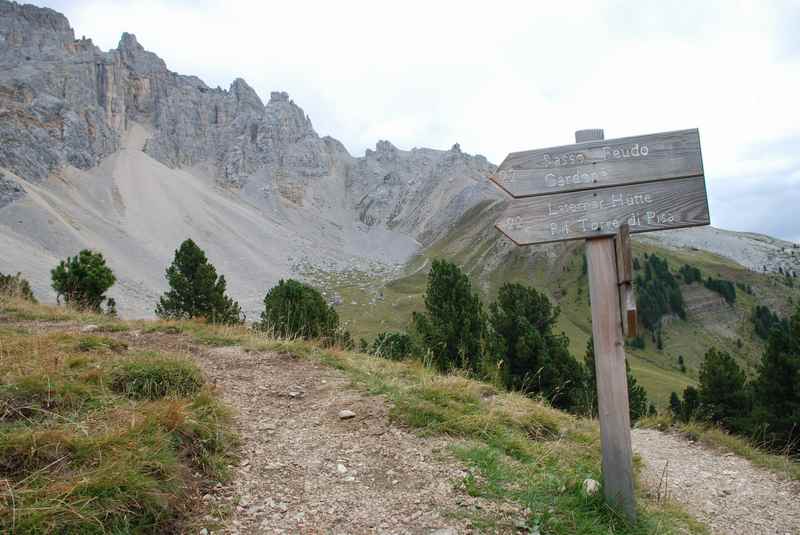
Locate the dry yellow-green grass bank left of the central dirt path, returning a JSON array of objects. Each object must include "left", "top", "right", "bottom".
[{"left": 0, "top": 298, "right": 236, "bottom": 533}]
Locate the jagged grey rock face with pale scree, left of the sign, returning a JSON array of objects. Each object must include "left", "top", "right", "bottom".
[{"left": 0, "top": 0, "right": 499, "bottom": 315}]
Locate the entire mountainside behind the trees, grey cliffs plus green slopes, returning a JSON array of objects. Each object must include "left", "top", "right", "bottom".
[{"left": 0, "top": 0, "right": 800, "bottom": 410}]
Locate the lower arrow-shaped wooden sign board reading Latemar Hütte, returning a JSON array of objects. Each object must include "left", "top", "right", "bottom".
[{"left": 496, "top": 176, "right": 710, "bottom": 245}]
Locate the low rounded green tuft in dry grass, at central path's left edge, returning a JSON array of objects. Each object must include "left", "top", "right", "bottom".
[{"left": 110, "top": 358, "right": 203, "bottom": 400}]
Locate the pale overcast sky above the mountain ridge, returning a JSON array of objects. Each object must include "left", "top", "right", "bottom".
[{"left": 35, "top": 0, "right": 800, "bottom": 241}]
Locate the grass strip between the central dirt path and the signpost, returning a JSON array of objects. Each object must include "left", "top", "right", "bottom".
[{"left": 245, "top": 337, "right": 706, "bottom": 534}]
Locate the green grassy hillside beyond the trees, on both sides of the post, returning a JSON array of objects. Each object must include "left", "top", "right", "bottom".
[{"left": 324, "top": 202, "right": 800, "bottom": 407}]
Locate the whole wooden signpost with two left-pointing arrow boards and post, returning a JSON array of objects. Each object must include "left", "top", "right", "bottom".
[{"left": 492, "top": 129, "right": 710, "bottom": 520}]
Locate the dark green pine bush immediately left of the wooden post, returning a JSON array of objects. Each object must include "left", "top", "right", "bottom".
[{"left": 488, "top": 284, "right": 586, "bottom": 410}]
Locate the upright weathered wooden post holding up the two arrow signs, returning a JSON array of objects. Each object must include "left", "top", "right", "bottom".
[{"left": 575, "top": 130, "right": 636, "bottom": 522}]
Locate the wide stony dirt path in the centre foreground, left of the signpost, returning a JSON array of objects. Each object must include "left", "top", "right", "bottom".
[{"left": 195, "top": 348, "right": 510, "bottom": 535}]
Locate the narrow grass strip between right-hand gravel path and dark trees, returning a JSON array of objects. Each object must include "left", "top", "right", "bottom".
[{"left": 638, "top": 416, "right": 800, "bottom": 481}]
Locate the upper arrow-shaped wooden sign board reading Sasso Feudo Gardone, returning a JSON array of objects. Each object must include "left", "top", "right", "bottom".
[{"left": 491, "top": 128, "right": 703, "bottom": 197}]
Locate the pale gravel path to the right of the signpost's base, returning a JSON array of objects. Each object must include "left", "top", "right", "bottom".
[{"left": 631, "top": 429, "right": 800, "bottom": 535}]
